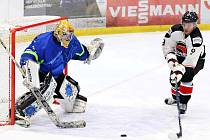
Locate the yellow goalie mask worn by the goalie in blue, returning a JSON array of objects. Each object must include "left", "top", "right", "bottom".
[{"left": 54, "top": 20, "right": 74, "bottom": 48}]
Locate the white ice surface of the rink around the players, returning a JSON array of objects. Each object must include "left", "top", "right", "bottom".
[{"left": 0, "top": 31, "right": 210, "bottom": 140}]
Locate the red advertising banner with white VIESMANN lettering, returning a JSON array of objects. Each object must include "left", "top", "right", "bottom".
[{"left": 106, "top": 0, "right": 201, "bottom": 26}]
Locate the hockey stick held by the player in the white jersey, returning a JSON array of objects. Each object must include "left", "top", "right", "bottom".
[{"left": 169, "top": 78, "right": 182, "bottom": 139}]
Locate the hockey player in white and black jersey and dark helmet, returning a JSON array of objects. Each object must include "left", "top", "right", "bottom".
[{"left": 162, "top": 11, "right": 206, "bottom": 114}]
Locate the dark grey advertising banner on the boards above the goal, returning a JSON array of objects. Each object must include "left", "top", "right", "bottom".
[{"left": 24, "top": 0, "right": 101, "bottom": 18}]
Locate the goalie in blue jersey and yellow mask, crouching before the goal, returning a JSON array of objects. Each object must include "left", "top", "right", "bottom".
[{"left": 15, "top": 20, "right": 104, "bottom": 123}]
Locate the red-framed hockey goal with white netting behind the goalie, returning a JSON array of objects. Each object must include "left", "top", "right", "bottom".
[{"left": 0, "top": 16, "right": 67, "bottom": 126}]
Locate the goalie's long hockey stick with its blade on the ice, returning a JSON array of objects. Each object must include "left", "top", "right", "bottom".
[{"left": 0, "top": 39, "right": 86, "bottom": 128}]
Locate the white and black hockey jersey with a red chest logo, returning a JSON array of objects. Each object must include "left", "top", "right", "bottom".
[{"left": 162, "top": 24, "right": 205, "bottom": 68}]
